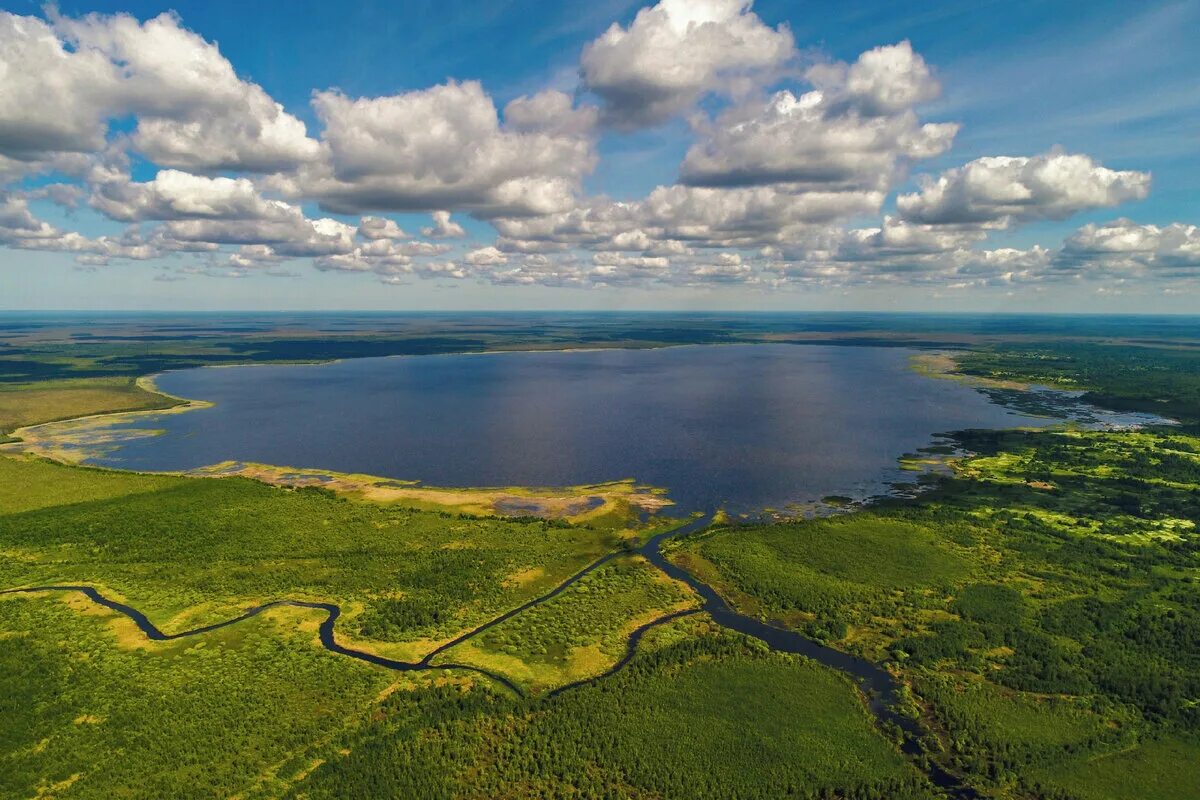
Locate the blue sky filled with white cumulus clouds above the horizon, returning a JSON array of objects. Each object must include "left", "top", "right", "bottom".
[{"left": 0, "top": 0, "right": 1200, "bottom": 313}]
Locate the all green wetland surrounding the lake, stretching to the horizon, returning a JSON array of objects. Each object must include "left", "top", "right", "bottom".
[{"left": 0, "top": 320, "right": 1200, "bottom": 800}]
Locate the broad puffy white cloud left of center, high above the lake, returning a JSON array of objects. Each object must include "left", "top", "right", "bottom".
[{"left": 285, "top": 82, "right": 595, "bottom": 216}]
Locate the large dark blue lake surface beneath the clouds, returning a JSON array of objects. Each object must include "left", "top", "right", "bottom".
[{"left": 82, "top": 344, "right": 1152, "bottom": 512}]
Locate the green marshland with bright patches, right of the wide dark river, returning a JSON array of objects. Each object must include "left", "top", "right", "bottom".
[{"left": 674, "top": 429, "right": 1200, "bottom": 800}]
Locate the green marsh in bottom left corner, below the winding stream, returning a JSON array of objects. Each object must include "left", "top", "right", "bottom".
[{"left": 0, "top": 597, "right": 390, "bottom": 800}]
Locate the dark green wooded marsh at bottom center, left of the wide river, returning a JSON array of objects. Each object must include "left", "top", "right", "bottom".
[{"left": 292, "top": 622, "right": 932, "bottom": 800}]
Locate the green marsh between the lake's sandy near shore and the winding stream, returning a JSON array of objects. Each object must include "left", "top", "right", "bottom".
[{"left": 0, "top": 458, "right": 633, "bottom": 640}]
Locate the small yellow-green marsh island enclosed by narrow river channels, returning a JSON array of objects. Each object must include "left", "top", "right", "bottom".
[{"left": 439, "top": 555, "right": 697, "bottom": 691}]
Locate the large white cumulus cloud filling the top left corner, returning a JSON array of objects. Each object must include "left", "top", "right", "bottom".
[{"left": 0, "top": 13, "right": 319, "bottom": 172}]
